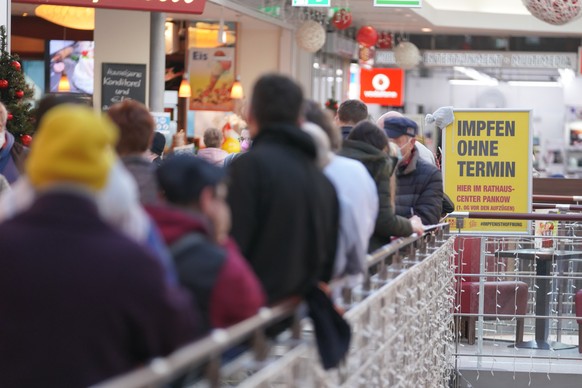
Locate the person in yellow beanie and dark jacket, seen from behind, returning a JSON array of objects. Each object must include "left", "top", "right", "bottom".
[{"left": 0, "top": 105, "right": 198, "bottom": 387}]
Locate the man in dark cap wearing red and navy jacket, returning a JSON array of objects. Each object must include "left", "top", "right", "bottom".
[{"left": 147, "top": 155, "right": 265, "bottom": 329}]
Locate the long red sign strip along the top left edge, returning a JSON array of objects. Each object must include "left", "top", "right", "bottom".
[{"left": 12, "top": 0, "right": 206, "bottom": 15}]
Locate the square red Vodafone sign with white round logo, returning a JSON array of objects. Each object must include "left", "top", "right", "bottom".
[{"left": 360, "top": 69, "right": 404, "bottom": 106}]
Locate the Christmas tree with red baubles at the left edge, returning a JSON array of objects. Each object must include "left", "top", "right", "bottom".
[{"left": 0, "top": 26, "right": 34, "bottom": 145}]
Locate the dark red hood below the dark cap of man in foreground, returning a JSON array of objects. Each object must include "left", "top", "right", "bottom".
[{"left": 146, "top": 206, "right": 208, "bottom": 245}]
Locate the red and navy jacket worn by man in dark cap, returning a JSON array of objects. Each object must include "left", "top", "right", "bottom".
[{"left": 147, "top": 206, "right": 265, "bottom": 330}]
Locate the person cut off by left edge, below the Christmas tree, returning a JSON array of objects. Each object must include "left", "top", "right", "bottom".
[{"left": 0, "top": 102, "right": 27, "bottom": 184}]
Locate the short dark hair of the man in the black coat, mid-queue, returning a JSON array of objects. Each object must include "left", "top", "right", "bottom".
[{"left": 250, "top": 74, "right": 303, "bottom": 127}]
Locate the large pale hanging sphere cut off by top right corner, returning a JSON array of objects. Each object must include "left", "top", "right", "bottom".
[{"left": 522, "top": 0, "right": 582, "bottom": 26}]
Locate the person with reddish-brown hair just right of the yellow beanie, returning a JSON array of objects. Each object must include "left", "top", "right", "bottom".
[{"left": 107, "top": 100, "right": 159, "bottom": 205}]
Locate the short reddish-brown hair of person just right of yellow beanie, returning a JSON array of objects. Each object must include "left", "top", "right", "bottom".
[{"left": 107, "top": 100, "right": 155, "bottom": 155}]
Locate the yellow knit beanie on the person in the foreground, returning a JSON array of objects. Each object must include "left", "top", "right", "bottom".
[{"left": 26, "top": 104, "right": 118, "bottom": 191}]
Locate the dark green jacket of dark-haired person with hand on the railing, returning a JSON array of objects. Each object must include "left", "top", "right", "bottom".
[{"left": 339, "top": 140, "right": 412, "bottom": 252}]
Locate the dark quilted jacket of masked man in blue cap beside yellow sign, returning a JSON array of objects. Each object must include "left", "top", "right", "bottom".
[{"left": 396, "top": 145, "right": 443, "bottom": 225}]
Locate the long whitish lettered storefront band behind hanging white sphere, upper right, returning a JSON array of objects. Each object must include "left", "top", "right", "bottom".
[{"left": 375, "top": 50, "right": 578, "bottom": 70}]
